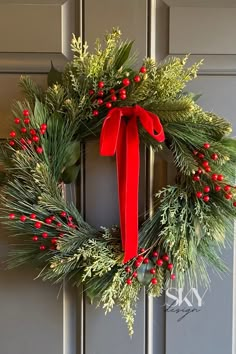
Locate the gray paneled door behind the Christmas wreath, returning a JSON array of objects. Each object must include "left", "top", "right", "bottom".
[{"left": 0, "top": 0, "right": 236, "bottom": 354}]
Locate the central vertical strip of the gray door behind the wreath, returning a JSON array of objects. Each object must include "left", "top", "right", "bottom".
[{"left": 81, "top": 0, "right": 151, "bottom": 354}]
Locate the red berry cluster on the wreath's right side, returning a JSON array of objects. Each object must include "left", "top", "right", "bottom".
[{"left": 193, "top": 143, "right": 236, "bottom": 207}]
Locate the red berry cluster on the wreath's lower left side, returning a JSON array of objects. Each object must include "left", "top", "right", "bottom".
[{"left": 9, "top": 211, "right": 77, "bottom": 251}]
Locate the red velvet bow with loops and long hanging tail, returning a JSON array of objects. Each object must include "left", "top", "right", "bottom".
[{"left": 100, "top": 106, "right": 165, "bottom": 263}]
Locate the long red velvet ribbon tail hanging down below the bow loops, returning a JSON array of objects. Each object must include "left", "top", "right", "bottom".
[{"left": 117, "top": 116, "right": 140, "bottom": 263}]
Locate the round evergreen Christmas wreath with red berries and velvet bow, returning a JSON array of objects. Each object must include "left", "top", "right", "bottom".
[{"left": 0, "top": 30, "right": 236, "bottom": 334}]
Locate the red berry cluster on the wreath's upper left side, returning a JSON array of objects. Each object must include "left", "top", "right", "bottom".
[{"left": 9, "top": 109, "right": 47, "bottom": 154}]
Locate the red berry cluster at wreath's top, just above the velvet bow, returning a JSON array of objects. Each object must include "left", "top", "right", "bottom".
[{"left": 89, "top": 66, "right": 147, "bottom": 117}]
